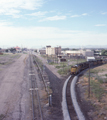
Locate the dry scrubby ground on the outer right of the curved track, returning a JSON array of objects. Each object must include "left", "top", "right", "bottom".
[{"left": 77, "top": 64, "right": 107, "bottom": 120}]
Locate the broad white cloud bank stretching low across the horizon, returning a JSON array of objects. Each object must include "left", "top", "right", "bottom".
[{"left": 0, "top": 26, "right": 107, "bottom": 47}]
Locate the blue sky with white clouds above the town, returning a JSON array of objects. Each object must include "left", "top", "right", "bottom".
[{"left": 0, "top": 0, "right": 107, "bottom": 48}]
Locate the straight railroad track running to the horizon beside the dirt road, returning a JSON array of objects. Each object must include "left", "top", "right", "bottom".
[{"left": 29, "top": 53, "right": 43, "bottom": 120}]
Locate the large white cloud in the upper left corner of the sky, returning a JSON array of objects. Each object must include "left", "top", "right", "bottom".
[{"left": 0, "top": 0, "right": 43, "bottom": 17}]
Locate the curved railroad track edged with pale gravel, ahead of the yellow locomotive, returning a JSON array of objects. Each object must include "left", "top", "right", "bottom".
[{"left": 62, "top": 74, "right": 85, "bottom": 120}]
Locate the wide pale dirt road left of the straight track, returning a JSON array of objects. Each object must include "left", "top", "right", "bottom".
[{"left": 0, "top": 54, "right": 30, "bottom": 120}]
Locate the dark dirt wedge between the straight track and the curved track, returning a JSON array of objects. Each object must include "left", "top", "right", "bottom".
[{"left": 33, "top": 54, "right": 66, "bottom": 120}]
